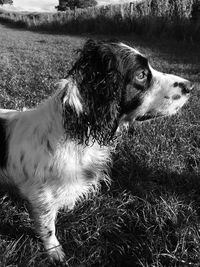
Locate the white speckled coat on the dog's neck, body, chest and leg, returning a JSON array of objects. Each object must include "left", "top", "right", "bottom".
[{"left": 1, "top": 80, "right": 110, "bottom": 261}]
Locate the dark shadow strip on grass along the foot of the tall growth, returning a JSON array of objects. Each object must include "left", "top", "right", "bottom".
[{"left": 0, "top": 21, "right": 200, "bottom": 64}]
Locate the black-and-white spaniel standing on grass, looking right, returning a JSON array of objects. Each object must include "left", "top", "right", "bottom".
[{"left": 0, "top": 40, "right": 193, "bottom": 262}]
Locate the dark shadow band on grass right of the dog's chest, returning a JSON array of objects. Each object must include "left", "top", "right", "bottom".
[{"left": 111, "top": 150, "right": 200, "bottom": 212}]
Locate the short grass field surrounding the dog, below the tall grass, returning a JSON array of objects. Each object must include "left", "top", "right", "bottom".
[{"left": 0, "top": 25, "right": 200, "bottom": 267}]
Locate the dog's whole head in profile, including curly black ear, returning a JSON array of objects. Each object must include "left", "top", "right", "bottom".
[{"left": 59, "top": 40, "right": 192, "bottom": 144}]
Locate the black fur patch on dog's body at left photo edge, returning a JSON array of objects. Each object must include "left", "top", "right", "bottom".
[{"left": 0, "top": 118, "right": 8, "bottom": 168}]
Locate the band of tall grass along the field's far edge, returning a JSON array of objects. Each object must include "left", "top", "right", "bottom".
[{"left": 0, "top": 0, "right": 200, "bottom": 41}]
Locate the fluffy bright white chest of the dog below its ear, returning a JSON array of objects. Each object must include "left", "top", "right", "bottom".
[{"left": 37, "top": 143, "right": 109, "bottom": 208}]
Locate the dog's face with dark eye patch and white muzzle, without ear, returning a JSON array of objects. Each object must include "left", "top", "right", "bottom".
[{"left": 121, "top": 54, "right": 193, "bottom": 122}]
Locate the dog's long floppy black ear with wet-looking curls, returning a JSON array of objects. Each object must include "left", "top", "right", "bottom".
[{"left": 69, "top": 40, "right": 123, "bottom": 145}]
